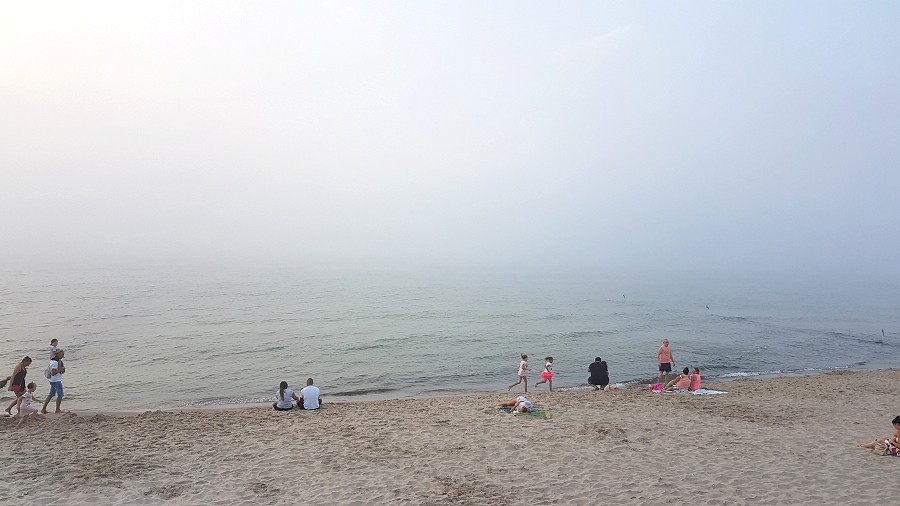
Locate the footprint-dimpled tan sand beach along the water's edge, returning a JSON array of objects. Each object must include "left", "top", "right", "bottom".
[{"left": 0, "top": 370, "right": 900, "bottom": 505}]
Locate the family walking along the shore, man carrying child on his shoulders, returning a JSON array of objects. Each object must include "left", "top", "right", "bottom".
[{"left": 0, "top": 339, "right": 66, "bottom": 426}]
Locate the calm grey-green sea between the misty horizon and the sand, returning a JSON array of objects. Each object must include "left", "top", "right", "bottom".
[{"left": 0, "top": 269, "right": 900, "bottom": 410}]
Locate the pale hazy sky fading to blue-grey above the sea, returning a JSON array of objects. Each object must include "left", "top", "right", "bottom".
[{"left": 0, "top": 1, "right": 900, "bottom": 275}]
